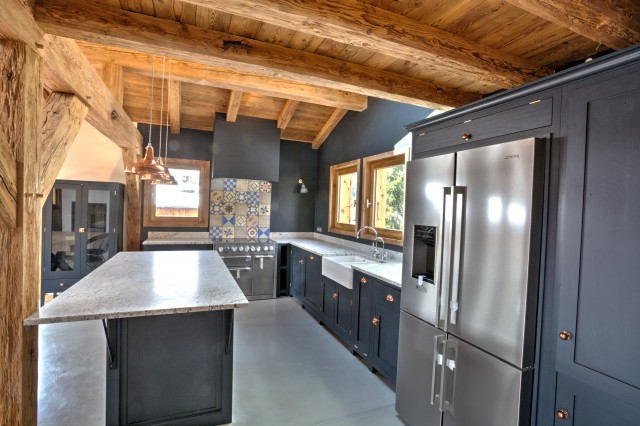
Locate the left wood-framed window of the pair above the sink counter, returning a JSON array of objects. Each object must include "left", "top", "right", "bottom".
[{"left": 329, "top": 160, "right": 360, "bottom": 236}]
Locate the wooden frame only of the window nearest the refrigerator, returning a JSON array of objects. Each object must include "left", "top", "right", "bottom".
[{"left": 360, "top": 149, "right": 409, "bottom": 246}]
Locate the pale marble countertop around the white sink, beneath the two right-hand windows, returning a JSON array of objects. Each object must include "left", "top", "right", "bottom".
[{"left": 272, "top": 237, "right": 402, "bottom": 288}]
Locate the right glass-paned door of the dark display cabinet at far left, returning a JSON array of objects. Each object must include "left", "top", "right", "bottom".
[{"left": 79, "top": 184, "right": 117, "bottom": 275}]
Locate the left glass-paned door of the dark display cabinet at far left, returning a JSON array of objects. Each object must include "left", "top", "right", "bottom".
[{"left": 42, "top": 183, "right": 84, "bottom": 279}]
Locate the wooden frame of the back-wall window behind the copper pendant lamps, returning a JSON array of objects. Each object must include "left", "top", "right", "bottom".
[{"left": 143, "top": 158, "right": 211, "bottom": 228}]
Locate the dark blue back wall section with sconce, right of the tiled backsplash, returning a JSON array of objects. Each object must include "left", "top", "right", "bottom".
[{"left": 271, "top": 141, "right": 318, "bottom": 232}]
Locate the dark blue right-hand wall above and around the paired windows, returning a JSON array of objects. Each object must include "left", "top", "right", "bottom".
[{"left": 315, "top": 98, "right": 432, "bottom": 248}]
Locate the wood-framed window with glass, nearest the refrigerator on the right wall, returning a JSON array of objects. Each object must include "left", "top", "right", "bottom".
[{"left": 361, "top": 150, "right": 408, "bottom": 245}]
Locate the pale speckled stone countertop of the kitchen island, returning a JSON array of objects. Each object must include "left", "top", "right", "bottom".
[{"left": 24, "top": 251, "right": 249, "bottom": 326}]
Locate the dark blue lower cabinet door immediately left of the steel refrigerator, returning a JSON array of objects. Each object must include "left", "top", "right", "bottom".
[{"left": 371, "top": 281, "right": 400, "bottom": 382}]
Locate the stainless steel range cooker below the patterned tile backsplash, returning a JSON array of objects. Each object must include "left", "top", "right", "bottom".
[{"left": 213, "top": 238, "right": 276, "bottom": 300}]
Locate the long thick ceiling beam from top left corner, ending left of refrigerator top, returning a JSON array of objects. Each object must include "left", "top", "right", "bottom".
[{"left": 36, "top": 0, "right": 480, "bottom": 109}]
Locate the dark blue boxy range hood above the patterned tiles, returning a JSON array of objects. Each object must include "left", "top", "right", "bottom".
[{"left": 212, "top": 114, "right": 280, "bottom": 182}]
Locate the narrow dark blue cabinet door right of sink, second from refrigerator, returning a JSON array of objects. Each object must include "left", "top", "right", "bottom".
[{"left": 351, "top": 272, "right": 373, "bottom": 361}]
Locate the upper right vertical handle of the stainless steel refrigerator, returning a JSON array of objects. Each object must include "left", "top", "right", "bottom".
[{"left": 445, "top": 186, "right": 467, "bottom": 331}]
